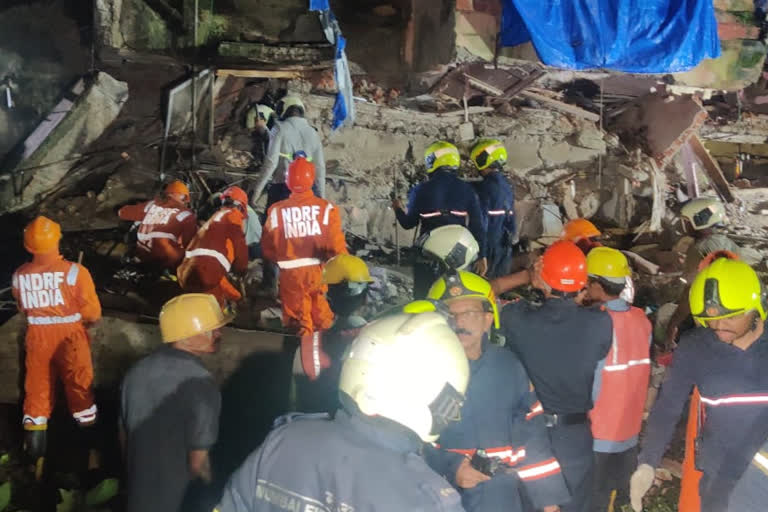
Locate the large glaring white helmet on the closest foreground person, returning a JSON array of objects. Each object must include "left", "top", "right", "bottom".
[{"left": 339, "top": 312, "right": 469, "bottom": 442}]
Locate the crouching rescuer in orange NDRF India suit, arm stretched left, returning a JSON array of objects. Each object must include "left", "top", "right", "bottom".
[{"left": 117, "top": 180, "right": 197, "bottom": 272}]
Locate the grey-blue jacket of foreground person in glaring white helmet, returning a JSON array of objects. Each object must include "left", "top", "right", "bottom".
[{"left": 216, "top": 410, "right": 464, "bottom": 512}]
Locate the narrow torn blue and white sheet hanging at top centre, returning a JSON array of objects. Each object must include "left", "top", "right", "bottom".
[{"left": 309, "top": 0, "right": 355, "bottom": 130}]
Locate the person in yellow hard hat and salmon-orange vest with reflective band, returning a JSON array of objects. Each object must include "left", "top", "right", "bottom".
[{"left": 586, "top": 247, "right": 652, "bottom": 512}]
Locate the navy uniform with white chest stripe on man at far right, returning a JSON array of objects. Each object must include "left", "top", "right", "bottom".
[{"left": 639, "top": 326, "right": 768, "bottom": 512}]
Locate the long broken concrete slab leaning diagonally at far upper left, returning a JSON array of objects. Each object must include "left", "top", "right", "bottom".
[{"left": 0, "top": 72, "right": 128, "bottom": 213}]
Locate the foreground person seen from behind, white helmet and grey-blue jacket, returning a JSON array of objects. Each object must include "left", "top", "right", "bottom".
[{"left": 216, "top": 313, "right": 469, "bottom": 512}]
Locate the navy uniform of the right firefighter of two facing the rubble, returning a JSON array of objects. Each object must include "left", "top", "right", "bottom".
[{"left": 475, "top": 171, "right": 516, "bottom": 279}]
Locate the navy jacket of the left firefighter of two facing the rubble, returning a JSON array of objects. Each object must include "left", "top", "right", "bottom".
[{"left": 395, "top": 168, "right": 485, "bottom": 258}]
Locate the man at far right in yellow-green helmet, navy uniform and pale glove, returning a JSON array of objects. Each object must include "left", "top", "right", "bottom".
[{"left": 631, "top": 258, "right": 768, "bottom": 512}]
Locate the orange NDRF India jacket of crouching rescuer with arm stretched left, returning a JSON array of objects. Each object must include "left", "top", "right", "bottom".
[{"left": 118, "top": 199, "right": 197, "bottom": 253}]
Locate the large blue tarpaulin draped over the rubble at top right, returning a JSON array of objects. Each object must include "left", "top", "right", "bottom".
[{"left": 501, "top": 0, "right": 720, "bottom": 73}]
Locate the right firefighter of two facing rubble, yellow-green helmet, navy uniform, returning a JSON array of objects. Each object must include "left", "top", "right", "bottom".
[{"left": 470, "top": 139, "right": 516, "bottom": 279}]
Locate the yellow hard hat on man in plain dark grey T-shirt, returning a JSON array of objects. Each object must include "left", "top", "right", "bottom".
[{"left": 160, "top": 293, "right": 235, "bottom": 343}]
